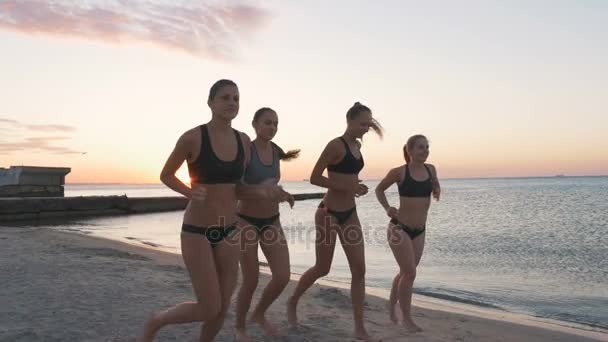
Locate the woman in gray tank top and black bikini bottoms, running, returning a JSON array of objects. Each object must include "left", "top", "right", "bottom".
[{"left": 236, "top": 107, "right": 300, "bottom": 341}]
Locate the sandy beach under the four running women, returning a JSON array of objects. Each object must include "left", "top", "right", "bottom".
[{"left": 0, "top": 227, "right": 608, "bottom": 342}]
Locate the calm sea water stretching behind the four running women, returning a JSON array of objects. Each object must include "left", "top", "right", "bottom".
[{"left": 23, "top": 177, "right": 608, "bottom": 329}]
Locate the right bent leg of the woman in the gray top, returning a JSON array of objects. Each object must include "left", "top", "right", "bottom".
[{"left": 251, "top": 221, "right": 290, "bottom": 336}]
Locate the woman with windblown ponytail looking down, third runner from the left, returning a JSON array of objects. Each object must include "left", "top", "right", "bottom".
[{"left": 287, "top": 102, "right": 382, "bottom": 341}]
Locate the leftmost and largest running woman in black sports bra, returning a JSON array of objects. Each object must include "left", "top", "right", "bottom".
[{"left": 138, "top": 80, "right": 287, "bottom": 341}]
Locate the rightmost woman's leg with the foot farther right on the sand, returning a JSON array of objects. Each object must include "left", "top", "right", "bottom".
[{"left": 388, "top": 224, "right": 422, "bottom": 332}]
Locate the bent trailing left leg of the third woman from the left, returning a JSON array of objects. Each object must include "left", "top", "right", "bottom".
[{"left": 287, "top": 209, "right": 336, "bottom": 326}]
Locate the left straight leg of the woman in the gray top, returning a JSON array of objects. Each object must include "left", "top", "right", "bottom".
[{"left": 236, "top": 226, "right": 260, "bottom": 342}]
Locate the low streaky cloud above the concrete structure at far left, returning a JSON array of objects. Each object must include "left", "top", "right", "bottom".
[{"left": 0, "top": 118, "right": 82, "bottom": 154}]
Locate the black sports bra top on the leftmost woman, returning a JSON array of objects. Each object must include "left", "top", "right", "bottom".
[{"left": 188, "top": 125, "right": 245, "bottom": 184}]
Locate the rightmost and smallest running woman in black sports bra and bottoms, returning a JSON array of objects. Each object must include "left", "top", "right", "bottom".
[{"left": 376, "top": 135, "right": 441, "bottom": 332}]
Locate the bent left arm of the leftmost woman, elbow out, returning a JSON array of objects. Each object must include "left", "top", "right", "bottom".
[{"left": 160, "top": 133, "right": 193, "bottom": 199}]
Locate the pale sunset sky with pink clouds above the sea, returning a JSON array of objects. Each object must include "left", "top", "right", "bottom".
[{"left": 0, "top": 0, "right": 608, "bottom": 183}]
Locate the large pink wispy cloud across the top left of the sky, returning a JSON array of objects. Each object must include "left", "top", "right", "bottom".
[{"left": 0, "top": 0, "right": 271, "bottom": 60}]
